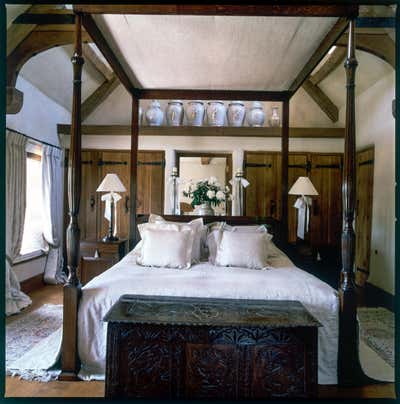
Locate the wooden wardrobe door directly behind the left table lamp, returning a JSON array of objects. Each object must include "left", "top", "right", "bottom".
[{"left": 98, "top": 151, "right": 130, "bottom": 239}]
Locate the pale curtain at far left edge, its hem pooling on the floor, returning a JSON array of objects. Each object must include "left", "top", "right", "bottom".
[{"left": 5, "top": 130, "right": 32, "bottom": 316}]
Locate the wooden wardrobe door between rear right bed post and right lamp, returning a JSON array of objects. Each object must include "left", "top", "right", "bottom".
[{"left": 288, "top": 154, "right": 307, "bottom": 243}]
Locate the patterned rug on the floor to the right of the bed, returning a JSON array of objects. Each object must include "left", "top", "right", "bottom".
[{"left": 357, "top": 307, "right": 394, "bottom": 368}]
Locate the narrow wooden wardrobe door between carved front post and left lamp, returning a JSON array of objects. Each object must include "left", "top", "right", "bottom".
[{"left": 79, "top": 151, "right": 101, "bottom": 240}]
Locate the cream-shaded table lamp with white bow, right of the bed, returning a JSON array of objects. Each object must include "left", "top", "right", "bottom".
[{"left": 289, "top": 177, "right": 318, "bottom": 252}]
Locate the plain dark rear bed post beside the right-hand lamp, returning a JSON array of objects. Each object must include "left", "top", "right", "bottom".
[{"left": 281, "top": 99, "right": 289, "bottom": 243}]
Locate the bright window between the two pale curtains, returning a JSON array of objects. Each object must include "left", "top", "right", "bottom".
[{"left": 20, "top": 152, "right": 45, "bottom": 255}]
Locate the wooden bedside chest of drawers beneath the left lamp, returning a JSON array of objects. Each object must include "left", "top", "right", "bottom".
[{"left": 79, "top": 239, "right": 128, "bottom": 285}]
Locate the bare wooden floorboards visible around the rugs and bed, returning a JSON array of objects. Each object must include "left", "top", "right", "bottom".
[{"left": 5, "top": 286, "right": 395, "bottom": 399}]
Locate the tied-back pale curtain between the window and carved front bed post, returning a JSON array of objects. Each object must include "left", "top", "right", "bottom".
[{"left": 42, "top": 145, "right": 66, "bottom": 284}]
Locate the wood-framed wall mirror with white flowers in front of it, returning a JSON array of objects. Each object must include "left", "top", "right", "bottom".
[{"left": 177, "top": 152, "right": 232, "bottom": 216}]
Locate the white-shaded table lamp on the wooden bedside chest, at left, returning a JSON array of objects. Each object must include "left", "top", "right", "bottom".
[{"left": 96, "top": 174, "right": 126, "bottom": 242}]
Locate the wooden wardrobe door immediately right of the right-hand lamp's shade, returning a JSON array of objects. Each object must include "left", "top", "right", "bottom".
[{"left": 310, "top": 154, "right": 342, "bottom": 247}]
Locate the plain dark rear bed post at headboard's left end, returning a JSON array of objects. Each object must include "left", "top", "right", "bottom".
[{"left": 129, "top": 94, "right": 139, "bottom": 250}]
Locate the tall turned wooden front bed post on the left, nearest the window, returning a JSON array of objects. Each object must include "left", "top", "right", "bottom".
[{"left": 59, "top": 14, "right": 84, "bottom": 380}]
